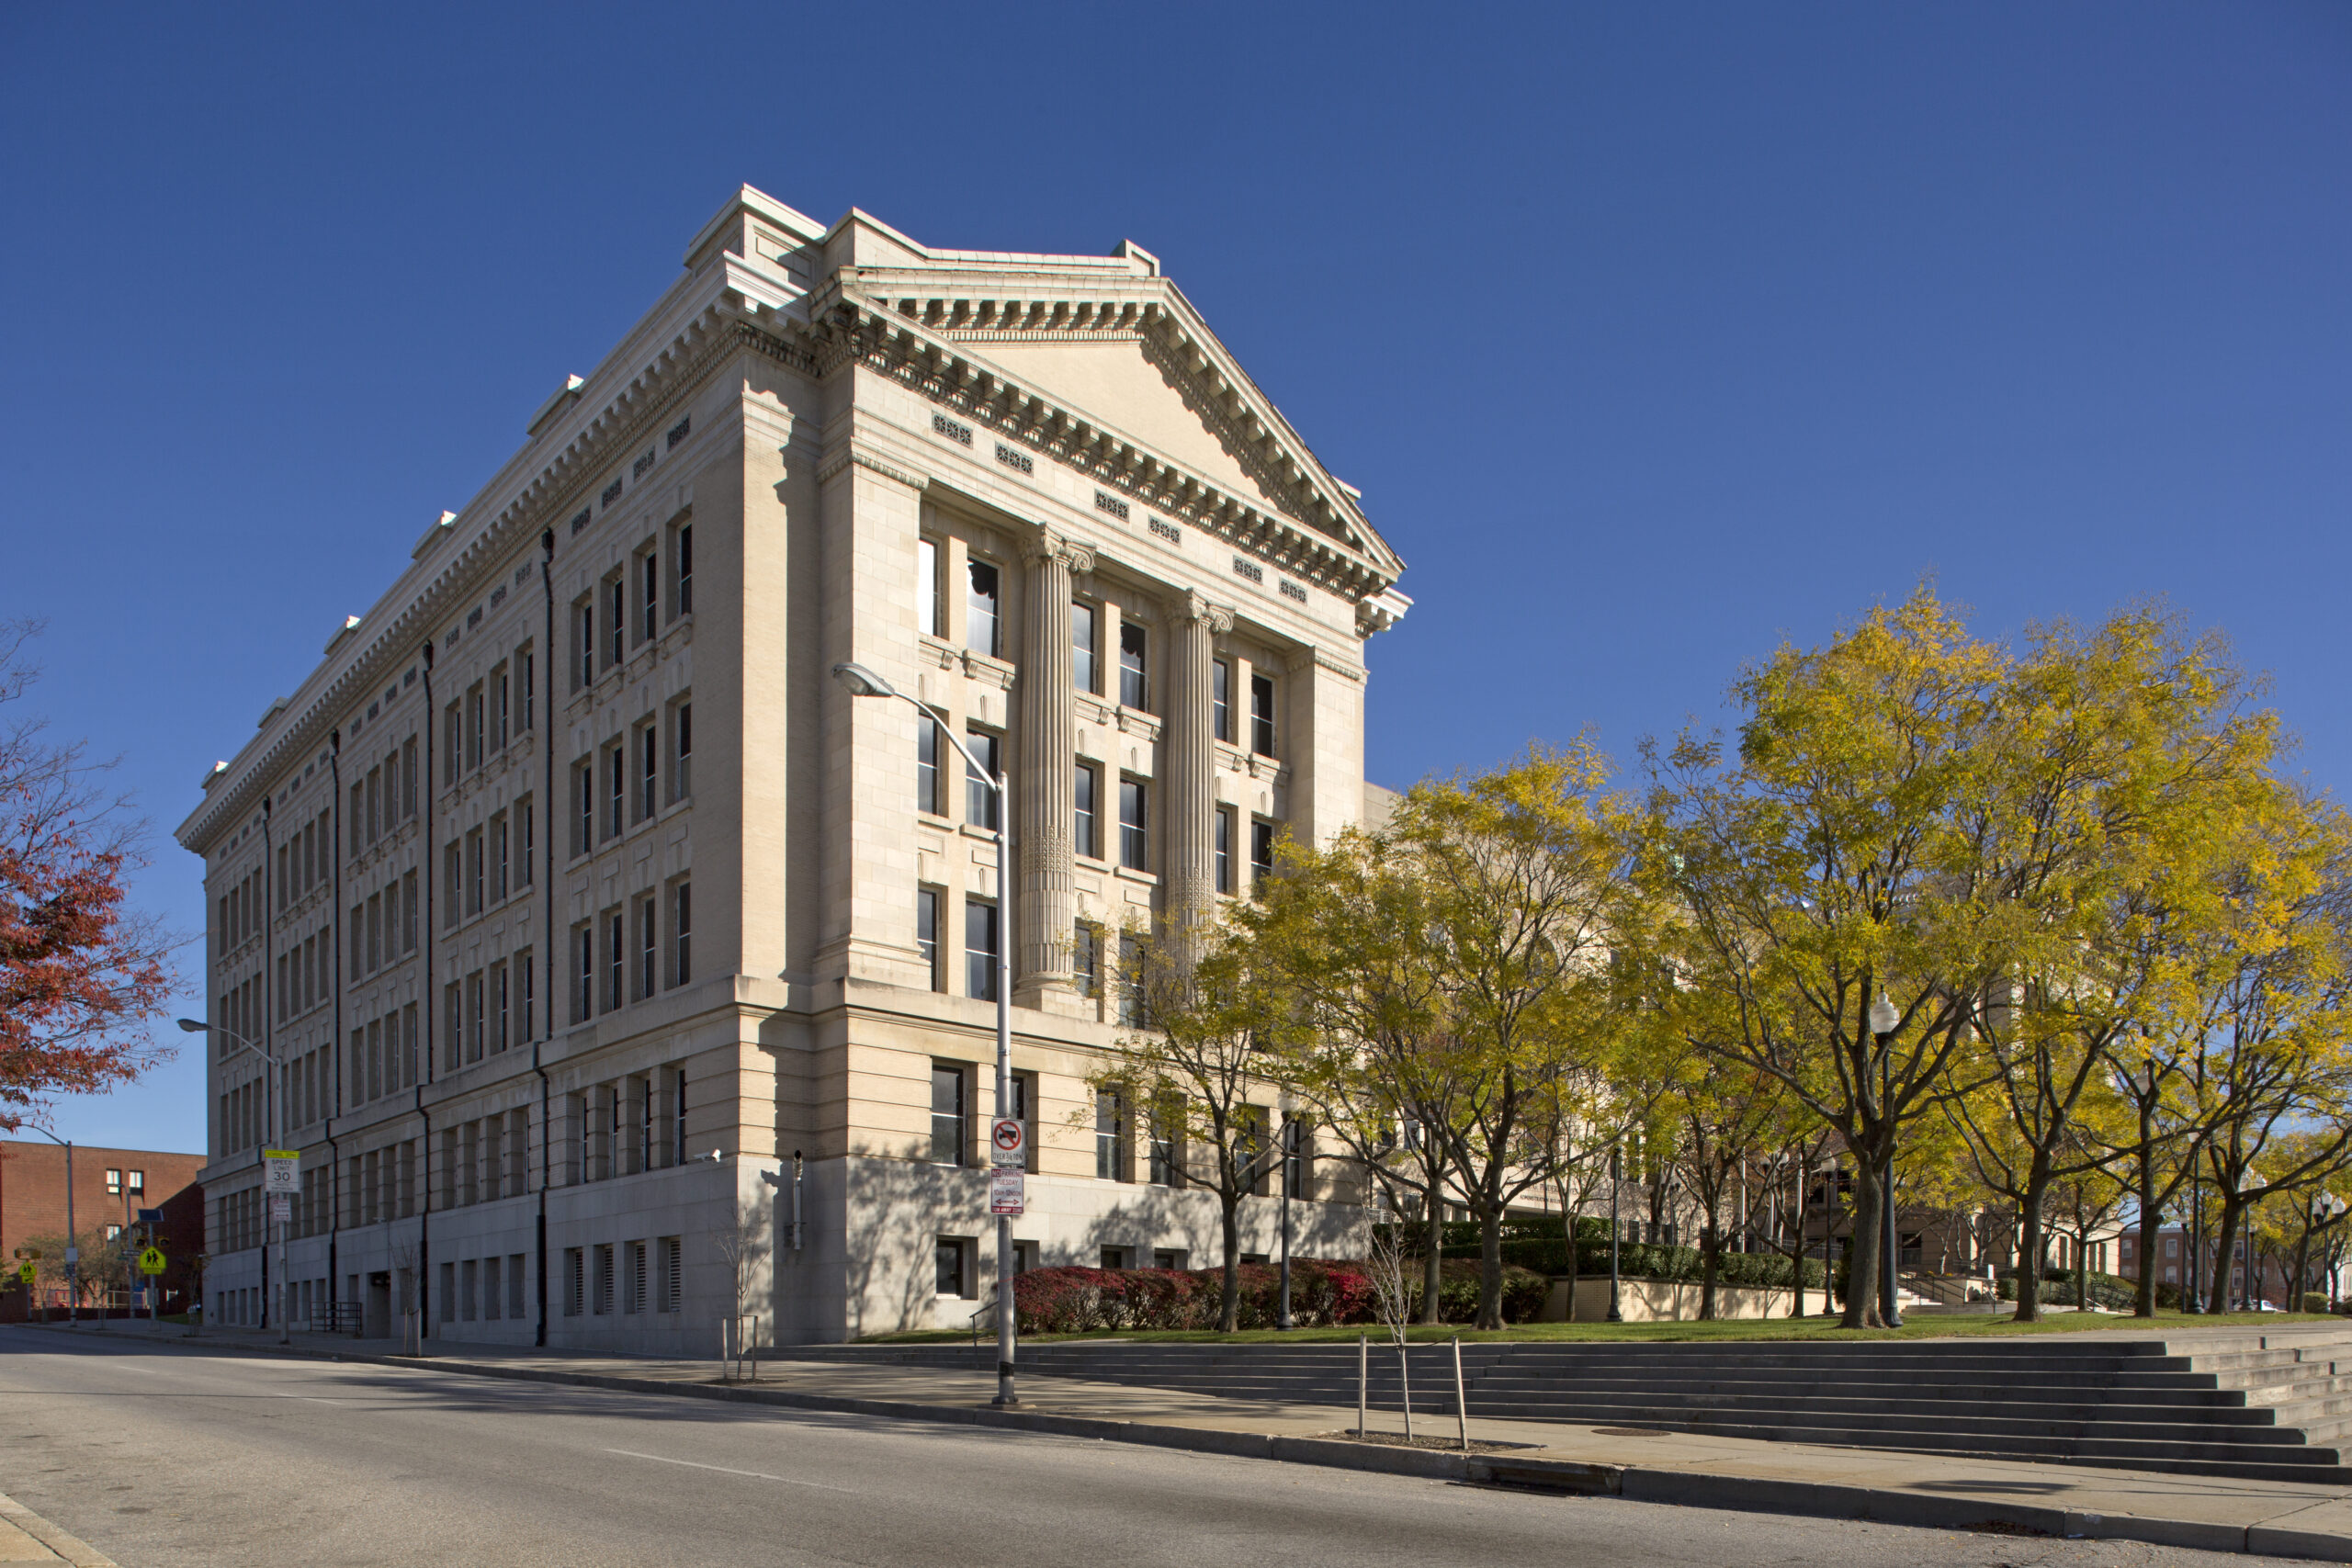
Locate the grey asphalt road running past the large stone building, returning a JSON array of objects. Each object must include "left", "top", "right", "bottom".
[{"left": 0, "top": 1328, "right": 2314, "bottom": 1568}]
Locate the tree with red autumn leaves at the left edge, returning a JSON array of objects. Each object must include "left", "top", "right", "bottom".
[{"left": 0, "top": 621, "right": 172, "bottom": 1131}]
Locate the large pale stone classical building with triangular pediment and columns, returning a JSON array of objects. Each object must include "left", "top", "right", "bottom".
[{"left": 179, "top": 188, "right": 1407, "bottom": 1349}]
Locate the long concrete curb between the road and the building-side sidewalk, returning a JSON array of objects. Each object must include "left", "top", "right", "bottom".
[{"left": 28, "top": 1324, "right": 2352, "bottom": 1568}]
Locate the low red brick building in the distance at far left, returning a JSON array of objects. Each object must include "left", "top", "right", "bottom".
[{"left": 0, "top": 1143, "right": 205, "bottom": 1321}]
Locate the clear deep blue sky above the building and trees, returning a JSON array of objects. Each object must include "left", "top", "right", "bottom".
[{"left": 0, "top": 0, "right": 2352, "bottom": 1149}]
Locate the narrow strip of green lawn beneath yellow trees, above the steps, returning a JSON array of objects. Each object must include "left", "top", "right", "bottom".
[{"left": 864, "top": 1309, "right": 2345, "bottom": 1345}]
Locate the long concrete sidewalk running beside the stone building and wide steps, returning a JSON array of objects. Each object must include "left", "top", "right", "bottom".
[{"left": 32, "top": 1324, "right": 2352, "bottom": 1561}]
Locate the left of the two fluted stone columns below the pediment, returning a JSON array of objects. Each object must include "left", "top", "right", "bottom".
[{"left": 1013, "top": 526, "right": 1093, "bottom": 1006}]
